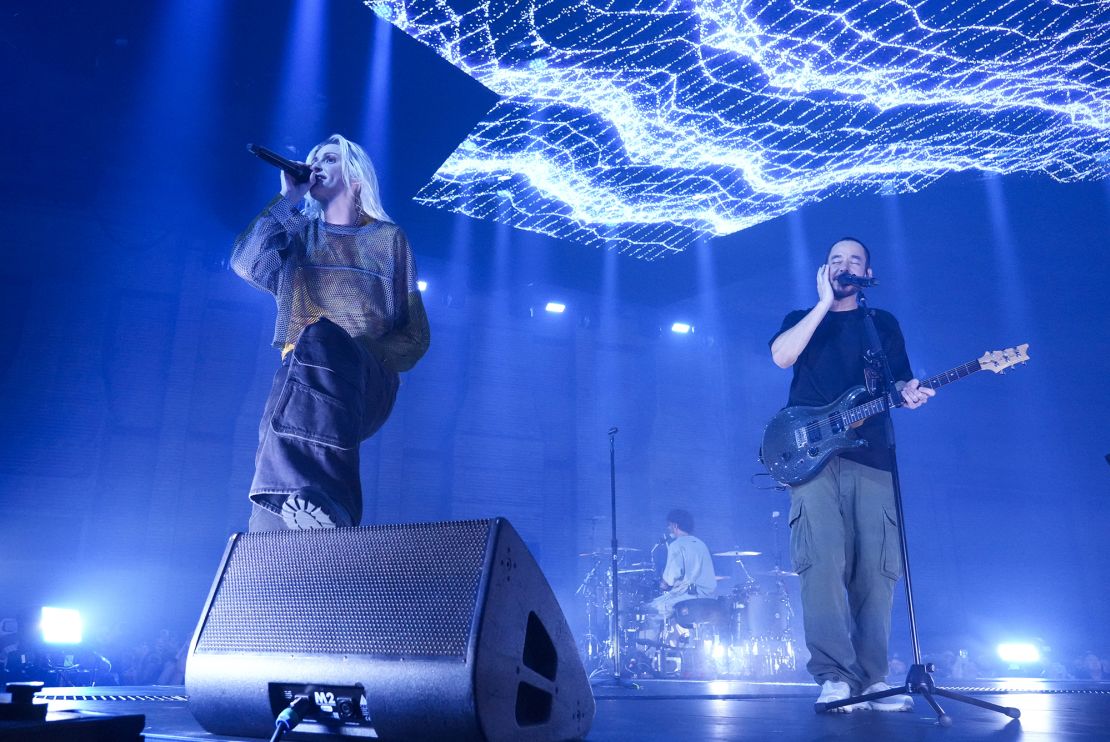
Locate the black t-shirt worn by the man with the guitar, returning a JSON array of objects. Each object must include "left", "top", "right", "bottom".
[{"left": 770, "top": 309, "right": 914, "bottom": 471}]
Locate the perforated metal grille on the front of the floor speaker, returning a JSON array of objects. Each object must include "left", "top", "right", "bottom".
[{"left": 195, "top": 521, "right": 492, "bottom": 661}]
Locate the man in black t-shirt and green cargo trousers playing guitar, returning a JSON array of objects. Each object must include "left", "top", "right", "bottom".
[{"left": 770, "top": 238, "right": 936, "bottom": 712}]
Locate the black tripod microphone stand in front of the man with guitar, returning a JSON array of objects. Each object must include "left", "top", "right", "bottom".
[{"left": 814, "top": 290, "right": 1021, "bottom": 726}]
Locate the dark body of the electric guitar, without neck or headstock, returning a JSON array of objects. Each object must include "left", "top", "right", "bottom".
[{"left": 759, "top": 387, "right": 868, "bottom": 485}]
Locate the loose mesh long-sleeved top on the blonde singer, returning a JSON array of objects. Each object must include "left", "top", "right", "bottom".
[{"left": 231, "top": 195, "right": 430, "bottom": 371}]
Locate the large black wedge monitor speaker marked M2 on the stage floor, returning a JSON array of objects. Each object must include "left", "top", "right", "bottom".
[{"left": 185, "top": 519, "right": 594, "bottom": 741}]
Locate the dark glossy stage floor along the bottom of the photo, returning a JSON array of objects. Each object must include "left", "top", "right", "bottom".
[{"left": 19, "top": 679, "right": 1110, "bottom": 742}]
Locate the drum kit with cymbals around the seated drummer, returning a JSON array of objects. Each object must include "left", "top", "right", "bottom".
[{"left": 577, "top": 535, "right": 798, "bottom": 680}]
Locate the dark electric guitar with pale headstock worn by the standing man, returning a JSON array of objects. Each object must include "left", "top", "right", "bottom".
[{"left": 759, "top": 343, "right": 1029, "bottom": 484}]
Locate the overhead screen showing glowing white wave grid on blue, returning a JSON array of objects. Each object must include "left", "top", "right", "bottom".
[{"left": 365, "top": 0, "right": 1110, "bottom": 260}]
